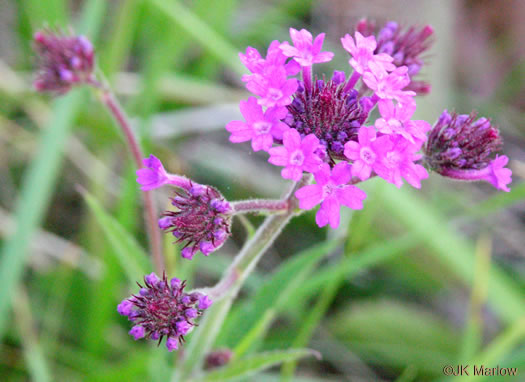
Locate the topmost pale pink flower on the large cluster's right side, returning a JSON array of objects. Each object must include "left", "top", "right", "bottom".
[{"left": 341, "top": 32, "right": 395, "bottom": 74}]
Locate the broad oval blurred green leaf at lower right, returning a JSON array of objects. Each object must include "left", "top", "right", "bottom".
[{"left": 328, "top": 300, "right": 460, "bottom": 376}]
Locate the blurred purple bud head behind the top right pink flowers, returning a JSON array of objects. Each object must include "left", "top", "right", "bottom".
[{"left": 356, "top": 19, "right": 434, "bottom": 95}]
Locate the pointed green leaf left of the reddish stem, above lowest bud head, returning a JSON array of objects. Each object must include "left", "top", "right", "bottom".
[{"left": 83, "top": 192, "right": 150, "bottom": 284}]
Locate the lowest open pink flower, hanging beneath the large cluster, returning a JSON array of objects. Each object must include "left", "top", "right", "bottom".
[{"left": 295, "top": 162, "right": 366, "bottom": 228}]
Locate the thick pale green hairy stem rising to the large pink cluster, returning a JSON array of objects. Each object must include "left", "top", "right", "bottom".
[{"left": 172, "top": 174, "right": 312, "bottom": 382}]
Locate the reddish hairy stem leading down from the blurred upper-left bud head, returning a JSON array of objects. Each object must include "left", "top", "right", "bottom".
[{"left": 90, "top": 80, "right": 164, "bottom": 275}]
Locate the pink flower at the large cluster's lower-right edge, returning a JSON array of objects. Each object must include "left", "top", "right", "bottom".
[{"left": 374, "top": 136, "right": 428, "bottom": 188}]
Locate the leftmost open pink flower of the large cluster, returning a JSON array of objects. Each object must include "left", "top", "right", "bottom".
[{"left": 226, "top": 97, "right": 288, "bottom": 151}]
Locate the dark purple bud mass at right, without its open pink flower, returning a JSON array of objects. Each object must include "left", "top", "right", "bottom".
[{"left": 424, "top": 110, "right": 502, "bottom": 173}]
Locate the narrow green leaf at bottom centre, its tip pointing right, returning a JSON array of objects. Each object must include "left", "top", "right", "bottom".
[{"left": 194, "top": 349, "right": 320, "bottom": 382}]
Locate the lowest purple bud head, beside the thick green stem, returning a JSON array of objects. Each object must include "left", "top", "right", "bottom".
[{"left": 117, "top": 273, "right": 212, "bottom": 351}]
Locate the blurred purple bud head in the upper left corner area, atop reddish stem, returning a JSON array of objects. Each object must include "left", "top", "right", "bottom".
[{"left": 33, "top": 30, "right": 95, "bottom": 94}]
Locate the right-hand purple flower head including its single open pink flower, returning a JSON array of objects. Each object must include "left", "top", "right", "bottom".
[{"left": 424, "top": 110, "right": 512, "bottom": 191}]
